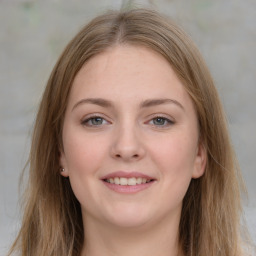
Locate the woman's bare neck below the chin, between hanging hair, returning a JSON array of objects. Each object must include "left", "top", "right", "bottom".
[{"left": 81, "top": 213, "right": 183, "bottom": 256}]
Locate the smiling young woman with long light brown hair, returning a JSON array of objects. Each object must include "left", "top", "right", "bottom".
[{"left": 10, "top": 9, "right": 252, "bottom": 256}]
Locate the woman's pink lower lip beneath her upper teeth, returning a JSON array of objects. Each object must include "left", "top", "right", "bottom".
[{"left": 103, "top": 181, "right": 155, "bottom": 194}]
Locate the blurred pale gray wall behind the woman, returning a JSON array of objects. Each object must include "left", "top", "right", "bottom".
[{"left": 0, "top": 0, "right": 256, "bottom": 255}]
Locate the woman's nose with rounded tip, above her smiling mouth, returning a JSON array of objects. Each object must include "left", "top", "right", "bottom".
[{"left": 111, "top": 123, "right": 146, "bottom": 162}]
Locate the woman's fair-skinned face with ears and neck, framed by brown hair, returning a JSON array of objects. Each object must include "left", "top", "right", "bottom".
[{"left": 60, "top": 45, "right": 205, "bottom": 256}]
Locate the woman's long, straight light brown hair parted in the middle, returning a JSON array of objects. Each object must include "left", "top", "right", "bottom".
[{"left": 10, "top": 9, "right": 250, "bottom": 256}]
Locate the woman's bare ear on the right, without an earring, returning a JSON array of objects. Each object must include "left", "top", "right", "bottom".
[{"left": 192, "top": 142, "right": 207, "bottom": 179}]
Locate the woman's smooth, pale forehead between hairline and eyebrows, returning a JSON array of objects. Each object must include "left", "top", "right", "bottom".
[{"left": 70, "top": 45, "right": 194, "bottom": 111}]
